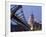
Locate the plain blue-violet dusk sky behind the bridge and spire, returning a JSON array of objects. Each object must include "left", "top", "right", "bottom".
[{"left": 11, "top": 5, "right": 42, "bottom": 22}]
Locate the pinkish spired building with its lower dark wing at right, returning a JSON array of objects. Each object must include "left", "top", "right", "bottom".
[{"left": 28, "top": 14, "right": 42, "bottom": 31}]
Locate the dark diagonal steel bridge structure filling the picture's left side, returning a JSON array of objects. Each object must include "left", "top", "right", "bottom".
[{"left": 10, "top": 5, "right": 30, "bottom": 32}]
